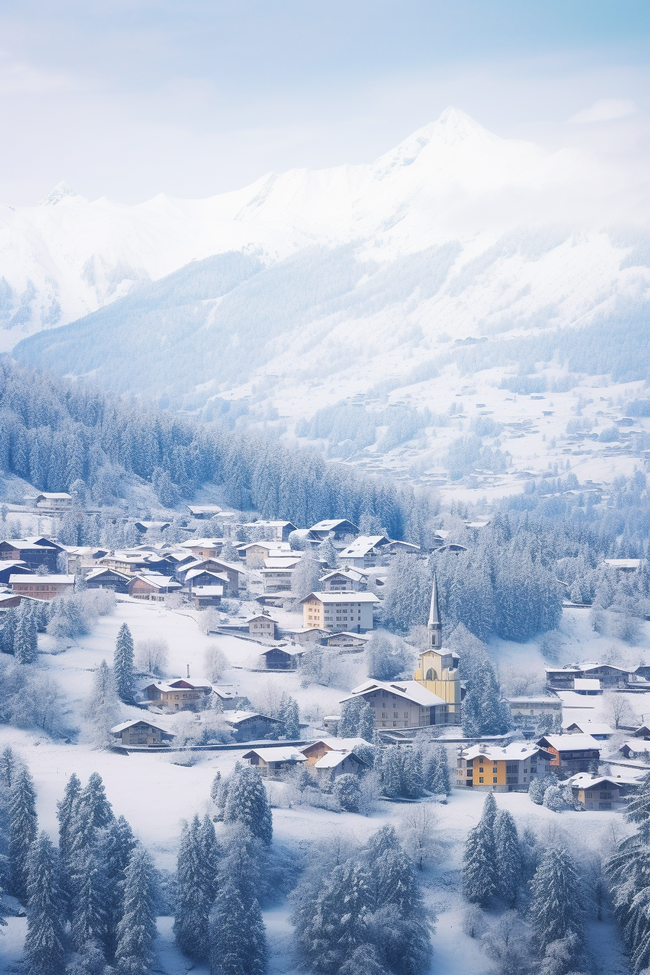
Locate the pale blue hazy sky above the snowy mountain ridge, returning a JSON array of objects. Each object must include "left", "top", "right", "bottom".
[{"left": 0, "top": 0, "right": 650, "bottom": 204}]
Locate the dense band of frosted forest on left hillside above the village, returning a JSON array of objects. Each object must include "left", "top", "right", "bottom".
[{"left": 0, "top": 357, "right": 429, "bottom": 541}]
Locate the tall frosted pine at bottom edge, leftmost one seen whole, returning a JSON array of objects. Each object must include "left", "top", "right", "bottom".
[{"left": 25, "top": 832, "right": 65, "bottom": 975}]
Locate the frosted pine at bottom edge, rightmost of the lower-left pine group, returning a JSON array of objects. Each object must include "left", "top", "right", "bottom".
[{"left": 115, "top": 844, "right": 156, "bottom": 975}]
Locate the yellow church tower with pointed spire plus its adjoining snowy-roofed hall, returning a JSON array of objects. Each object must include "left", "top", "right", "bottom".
[{"left": 341, "top": 577, "right": 461, "bottom": 731}]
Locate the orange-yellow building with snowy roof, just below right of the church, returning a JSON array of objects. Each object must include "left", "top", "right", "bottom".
[{"left": 456, "top": 741, "right": 551, "bottom": 792}]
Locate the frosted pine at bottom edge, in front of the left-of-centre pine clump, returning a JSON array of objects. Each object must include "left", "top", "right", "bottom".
[{"left": 210, "top": 876, "right": 268, "bottom": 975}]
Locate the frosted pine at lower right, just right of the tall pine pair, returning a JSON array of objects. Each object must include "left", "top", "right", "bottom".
[{"left": 530, "top": 849, "right": 585, "bottom": 950}]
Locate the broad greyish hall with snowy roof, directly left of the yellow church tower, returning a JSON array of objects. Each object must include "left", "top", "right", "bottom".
[{"left": 341, "top": 680, "right": 449, "bottom": 730}]
